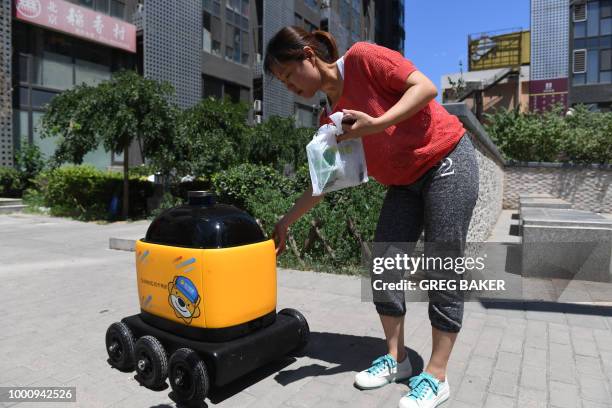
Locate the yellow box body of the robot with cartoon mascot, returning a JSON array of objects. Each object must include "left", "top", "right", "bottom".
[{"left": 135, "top": 240, "right": 276, "bottom": 328}]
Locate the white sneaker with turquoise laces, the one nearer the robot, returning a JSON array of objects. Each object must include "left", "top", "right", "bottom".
[{"left": 355, "top": 354, "right": 412, "bottom": 390}]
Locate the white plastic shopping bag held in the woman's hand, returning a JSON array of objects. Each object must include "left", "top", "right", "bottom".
[{"left": 306, "top": 112, "right": 368, "bottom": 196}]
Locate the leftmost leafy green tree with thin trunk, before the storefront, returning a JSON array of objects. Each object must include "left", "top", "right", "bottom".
[{"left": 42, "top": 71, "right": 177, "bottom": 218}]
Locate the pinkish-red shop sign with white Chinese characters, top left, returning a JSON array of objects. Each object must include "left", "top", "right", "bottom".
[{"left": 15, "top": 0, "right": 136, "bottom": 52}]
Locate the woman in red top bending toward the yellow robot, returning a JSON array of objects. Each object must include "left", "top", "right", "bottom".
[{"left": 264, "top": 27, "right": 478, "bottom": 408}]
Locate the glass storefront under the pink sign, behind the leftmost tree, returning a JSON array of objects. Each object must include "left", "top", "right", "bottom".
[{"left": 12, "top": 0, "right": 136, "bottom": 168}]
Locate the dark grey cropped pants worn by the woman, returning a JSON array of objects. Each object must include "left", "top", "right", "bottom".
[{"left": 372, "top": 132, "right": 479, "bottom": 333}]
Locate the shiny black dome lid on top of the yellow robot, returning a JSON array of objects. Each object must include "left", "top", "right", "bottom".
[{"left": 144, "top": 192, "right": 266, "bottom": 248}]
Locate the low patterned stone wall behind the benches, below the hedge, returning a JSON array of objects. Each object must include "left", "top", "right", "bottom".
[{"left": 503, "top": 162, "right": 612, "bottom": 213}]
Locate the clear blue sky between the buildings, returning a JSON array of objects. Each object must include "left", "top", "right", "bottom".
[{"left": 404, "top": 0, "right": 530, "bottom": 98}]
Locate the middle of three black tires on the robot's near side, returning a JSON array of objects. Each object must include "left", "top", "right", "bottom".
[{"left": 134, "top": 336, "right": 168, "bottom": 389}]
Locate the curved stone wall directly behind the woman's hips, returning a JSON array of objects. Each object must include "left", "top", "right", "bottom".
[{"left": 443, "top": 103, "right": 505, "bottom": 242}]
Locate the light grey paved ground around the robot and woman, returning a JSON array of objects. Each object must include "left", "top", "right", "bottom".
[{"left": 0, "top": 211, "right": 612, "bottom": 408}]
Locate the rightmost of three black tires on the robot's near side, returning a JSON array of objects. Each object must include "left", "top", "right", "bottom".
[{"left": 168, "top": 348, "right": 210, "bottom": 403}]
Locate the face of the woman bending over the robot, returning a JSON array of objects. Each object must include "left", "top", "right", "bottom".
[{"left": 272, "top": 47, "right": 321, "bottom": 98}]
